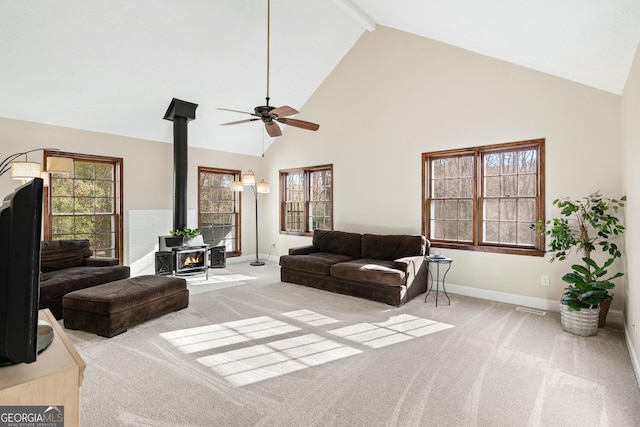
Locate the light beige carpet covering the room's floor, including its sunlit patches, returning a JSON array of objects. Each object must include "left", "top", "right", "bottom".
[{"left": 62, "top": 263, "right": 640, "bottom": 427}]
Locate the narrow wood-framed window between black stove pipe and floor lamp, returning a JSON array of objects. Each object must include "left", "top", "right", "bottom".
[{"left": 198, "top": 167, "right": 241, "bottom": 256}]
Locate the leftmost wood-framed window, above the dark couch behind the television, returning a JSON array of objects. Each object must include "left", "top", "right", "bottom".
[{"left": 44, "top": 151, "right": 123, "bottom": 260}]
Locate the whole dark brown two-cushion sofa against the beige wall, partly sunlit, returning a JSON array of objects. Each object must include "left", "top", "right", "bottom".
[{"left": 280, "top": 230, "right": 430, "bottom": 306}]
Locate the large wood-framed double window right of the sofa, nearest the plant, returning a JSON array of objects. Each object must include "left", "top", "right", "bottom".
[{"left": 422, "top": 139, "right": 544, "bottom": 256}]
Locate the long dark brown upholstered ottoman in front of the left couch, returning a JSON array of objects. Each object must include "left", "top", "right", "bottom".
[{"left": 62, "top": 275, "right": 189, "bottom": 337}]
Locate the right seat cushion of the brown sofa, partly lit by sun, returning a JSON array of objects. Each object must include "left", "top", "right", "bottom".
[{"left": 331, "top": 259, "right": 405, "bottom": 286}]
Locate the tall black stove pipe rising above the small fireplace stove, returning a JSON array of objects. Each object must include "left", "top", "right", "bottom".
[{"left": 163, "top": 98, "right": 198, "bottom": 230}]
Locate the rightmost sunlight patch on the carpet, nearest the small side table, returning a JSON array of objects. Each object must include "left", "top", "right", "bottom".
[{"left": 328, "top": 314, "right": 453, "bottom": 348}]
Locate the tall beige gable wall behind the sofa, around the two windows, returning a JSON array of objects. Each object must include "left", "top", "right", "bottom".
[{"left": 265, "top": 26, "right": 624, "bottom": 310}]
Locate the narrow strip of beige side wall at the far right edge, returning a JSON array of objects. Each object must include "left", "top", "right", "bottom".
[{"left": 621, "top": 41, "right": 640, "bottom": 378}]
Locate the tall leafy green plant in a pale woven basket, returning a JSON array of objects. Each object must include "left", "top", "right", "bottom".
[{"left": 531, "top": 191, "right": 627, "bottom": 336}]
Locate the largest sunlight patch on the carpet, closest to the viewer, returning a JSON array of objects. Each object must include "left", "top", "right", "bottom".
[{"left": 197, "top": 334, "right": 362, "bottom": 387}]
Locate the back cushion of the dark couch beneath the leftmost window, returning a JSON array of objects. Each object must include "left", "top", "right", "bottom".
[{"left": 40, "top": 239, "right": 93, "bottom": 272}]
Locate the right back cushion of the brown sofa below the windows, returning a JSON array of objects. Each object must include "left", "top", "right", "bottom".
[{"left": 362, "top": 234, "right": 427, "bottom": 261}]
